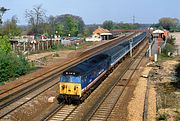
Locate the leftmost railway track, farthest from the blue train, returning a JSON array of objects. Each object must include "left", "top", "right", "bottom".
[{"left": 0, "top": 33, "right": 136, "bottom": 99}]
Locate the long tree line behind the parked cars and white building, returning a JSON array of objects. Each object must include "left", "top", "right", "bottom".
[{"left": 0, "top": 5, "right": 143, "bottom": 37}]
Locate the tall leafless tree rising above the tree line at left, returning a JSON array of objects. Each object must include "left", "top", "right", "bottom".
[{"left": 25, "top": 5, "right": 46, "bottom": 34}]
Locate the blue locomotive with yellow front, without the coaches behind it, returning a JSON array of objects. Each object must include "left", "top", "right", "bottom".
[{"left": 58, "top": 54, "right": 110, "bottom": 103}]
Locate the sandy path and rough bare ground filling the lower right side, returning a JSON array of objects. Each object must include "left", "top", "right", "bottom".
[{"left": 128, "top": 33, "right": 180, "bottom": 121}]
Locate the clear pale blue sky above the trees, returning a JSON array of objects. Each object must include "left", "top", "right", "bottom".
[{"left": 0, "top": 0, "right": 180, "bottom": 25}]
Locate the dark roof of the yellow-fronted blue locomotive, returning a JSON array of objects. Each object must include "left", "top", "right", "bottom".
[{"left": 63, "top": 54, "right": 109, "bottom": 75}]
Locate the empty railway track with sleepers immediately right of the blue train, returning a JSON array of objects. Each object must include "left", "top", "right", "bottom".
[{"left": 83, "top": 39, "right": 145, "bottom": 121}]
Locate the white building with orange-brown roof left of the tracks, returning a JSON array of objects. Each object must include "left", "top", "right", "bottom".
[{"left": 86, "top": 27, "right": 112, "bottom": 41}]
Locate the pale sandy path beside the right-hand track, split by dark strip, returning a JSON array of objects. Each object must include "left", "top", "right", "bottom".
[{"left": 128, "top": 67, "right": 156, "bottom": 121}]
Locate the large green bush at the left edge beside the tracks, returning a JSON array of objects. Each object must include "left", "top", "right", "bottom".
[{"left": 0, "top": 36, "right": 31, "bottom": 85}]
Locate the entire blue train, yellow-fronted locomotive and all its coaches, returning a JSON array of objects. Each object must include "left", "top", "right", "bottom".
[{"left": 58, "top": 32, "right": 146, "bottom": 103}]
